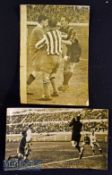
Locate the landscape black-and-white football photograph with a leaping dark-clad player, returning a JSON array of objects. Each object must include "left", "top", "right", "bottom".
[{"left": 4, "top": 108, "right": 109, "bottom": 170}]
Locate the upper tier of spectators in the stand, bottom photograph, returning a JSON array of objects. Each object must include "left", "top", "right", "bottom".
[{"left": 7, "top": 110, "right": 107, "bottom": 124}]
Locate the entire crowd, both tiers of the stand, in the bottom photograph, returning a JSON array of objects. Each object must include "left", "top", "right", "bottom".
[{"left": 6, "top": 110, "right": 108, "bottom": 134}]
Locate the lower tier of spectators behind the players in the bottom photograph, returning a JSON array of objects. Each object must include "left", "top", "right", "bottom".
[{"left": 7, "top": 122, "right": 108, "bottom": 134}]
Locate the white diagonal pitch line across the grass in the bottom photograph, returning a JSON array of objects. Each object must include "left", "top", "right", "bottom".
[{"left": 41, "top": 154, "right": 103, "bottom": 165}]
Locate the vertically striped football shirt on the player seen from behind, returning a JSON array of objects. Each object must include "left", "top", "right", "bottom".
[{"left": 35, "top": 30, "right": 67, "bottom": 55}]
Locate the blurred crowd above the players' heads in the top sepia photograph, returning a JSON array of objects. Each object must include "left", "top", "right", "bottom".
[{"left": 27, "top": 5, "right": 88, "bottom": 23}]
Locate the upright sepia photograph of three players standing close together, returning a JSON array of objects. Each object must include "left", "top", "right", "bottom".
[{"left": 20, "top": 4, "right": 90, "bottom": 106}]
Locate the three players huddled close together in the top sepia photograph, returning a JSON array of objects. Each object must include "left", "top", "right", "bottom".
[{"left": 27, "top": 15, "right": 81, "bottom": 101}]
